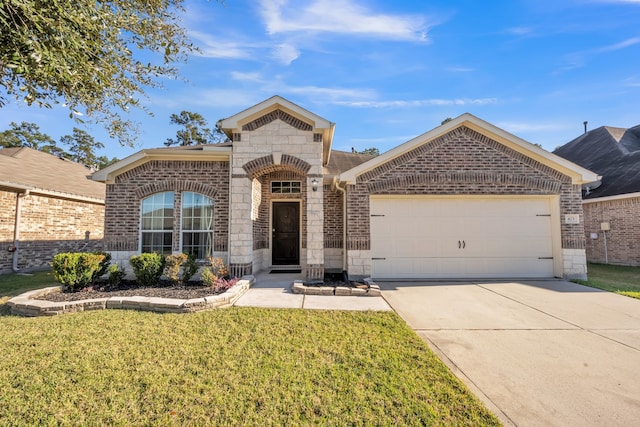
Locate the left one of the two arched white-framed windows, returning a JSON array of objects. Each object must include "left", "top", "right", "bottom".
[{"left": 140, "top": 191, "right": 173, "bottom": 254}]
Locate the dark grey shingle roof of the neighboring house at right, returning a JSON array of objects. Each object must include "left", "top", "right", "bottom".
[{"left": 554, "top": 125, "right": 640, "bottom": 199}]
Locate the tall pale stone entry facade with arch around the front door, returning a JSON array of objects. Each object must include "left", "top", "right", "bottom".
[{"left": 230, "top": 117, "right": 324, "bottom": 276}]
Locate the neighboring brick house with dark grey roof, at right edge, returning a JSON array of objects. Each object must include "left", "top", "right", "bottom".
[{"left": 554, "top": 125, "right": 640, "bottom": 265}]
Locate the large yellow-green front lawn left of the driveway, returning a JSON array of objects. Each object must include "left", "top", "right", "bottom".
[{"left": 0, "top": 307, "right": 499, "bottom": 426}]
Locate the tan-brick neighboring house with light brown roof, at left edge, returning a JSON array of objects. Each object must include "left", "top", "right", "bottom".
[{"left": 0, "top": 147, "right": 105, "bottom": 273}]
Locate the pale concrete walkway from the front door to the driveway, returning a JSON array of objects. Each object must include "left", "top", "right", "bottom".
[{"left": 235, "top": 272, "right": 391, "bottom": 311}]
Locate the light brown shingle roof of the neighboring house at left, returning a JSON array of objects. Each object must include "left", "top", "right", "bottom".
[{"left": 0, "top": 147, "right": 105, "bottom": 202}]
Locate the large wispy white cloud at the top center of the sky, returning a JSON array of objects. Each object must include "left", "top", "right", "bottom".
[{"left": 260, "top": 0, "right": 427, "bottom": 41}]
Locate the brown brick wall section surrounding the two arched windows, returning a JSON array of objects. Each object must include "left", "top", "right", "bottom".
[{"left": 105, "top": 160, "right": 229, "bottom": 252}]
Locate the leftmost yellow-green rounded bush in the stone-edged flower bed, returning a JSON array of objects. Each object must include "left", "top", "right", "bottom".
[{"left": 51, "top": 252, "right": 105, "bottom": 292}]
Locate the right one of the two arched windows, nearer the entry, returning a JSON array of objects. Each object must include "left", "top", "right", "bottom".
[{"left": 182, "top": 192, "right": 213, "bottom": 259}]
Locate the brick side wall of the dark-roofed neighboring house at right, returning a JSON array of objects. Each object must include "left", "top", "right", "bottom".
[{"left": 582, "top": 197, "right": 640, "bottom": 266}]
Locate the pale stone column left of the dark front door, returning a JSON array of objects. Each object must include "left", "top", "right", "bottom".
[{"left": 229, "top": 177, "right": 253, "bottom": 277}]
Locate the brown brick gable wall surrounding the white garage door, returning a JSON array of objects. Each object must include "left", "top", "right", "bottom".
[{"left": 347, "top": 127, "right": 585, "bottom": 275}]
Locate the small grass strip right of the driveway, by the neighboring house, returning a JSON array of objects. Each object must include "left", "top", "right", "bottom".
[{"left": 576, "top": 263, "right": 640, "bottom": 299}]
